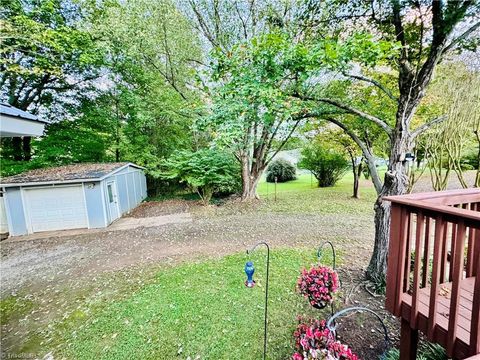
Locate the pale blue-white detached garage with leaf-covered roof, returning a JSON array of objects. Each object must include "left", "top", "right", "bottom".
[{"left": 0, "top": 163, "right": 147, "bottom": 236}]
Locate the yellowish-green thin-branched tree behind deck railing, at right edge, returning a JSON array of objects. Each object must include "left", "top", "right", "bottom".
[{"left": 419, "top": 61, "right": 480, "bottom": 190}]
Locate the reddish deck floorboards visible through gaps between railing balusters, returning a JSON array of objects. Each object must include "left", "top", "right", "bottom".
[{"left": 402, "top": 277, "right": 475, "bottom": 358}]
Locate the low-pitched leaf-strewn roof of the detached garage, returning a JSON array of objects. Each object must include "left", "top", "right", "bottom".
[{"left": 0, "top": 162, "right": 143, "bottom": 187}]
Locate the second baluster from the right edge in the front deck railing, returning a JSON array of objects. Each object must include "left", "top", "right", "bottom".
[{"left": 447, "top": 220, "right": 466, "bottom": 357}]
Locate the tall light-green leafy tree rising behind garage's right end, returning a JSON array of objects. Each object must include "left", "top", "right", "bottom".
[{"left": 90, "top": 0, "right": 203, "bottom": 183}]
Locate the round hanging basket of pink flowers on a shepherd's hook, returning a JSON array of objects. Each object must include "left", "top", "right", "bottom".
[{"left": 297, "top": 266, "right": 338, "bottom": 309}]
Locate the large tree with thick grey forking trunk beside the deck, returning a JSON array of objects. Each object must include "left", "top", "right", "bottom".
[{"left": 297, "top": 0, "right": 480, "bottom": 280}]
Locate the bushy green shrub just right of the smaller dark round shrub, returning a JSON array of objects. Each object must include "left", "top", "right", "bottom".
[{"left": 299, "top": 144, "right": 349, "bottom": 187}]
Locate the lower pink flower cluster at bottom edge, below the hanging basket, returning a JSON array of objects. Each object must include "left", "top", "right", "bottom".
[{"left": 292, "top": 318, "right": 359, "bottom": 360}]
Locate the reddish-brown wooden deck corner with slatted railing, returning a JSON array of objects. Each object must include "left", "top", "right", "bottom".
[{"left": 385, "top": 189, "right": 480, "bottom": 360}]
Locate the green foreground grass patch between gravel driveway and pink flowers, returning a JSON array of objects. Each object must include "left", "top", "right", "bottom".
[{"left": 54, "top": 249, "right": 336, "bottom": 360}]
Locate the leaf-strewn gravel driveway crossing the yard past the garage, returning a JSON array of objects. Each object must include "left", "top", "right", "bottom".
[{"left": 0, "top": 204, "right": 373, "bottom": 297}]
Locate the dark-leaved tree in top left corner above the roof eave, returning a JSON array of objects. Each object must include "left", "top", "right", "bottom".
[{"left": 0, "top": 0, "right": 103, "bottom": 160}]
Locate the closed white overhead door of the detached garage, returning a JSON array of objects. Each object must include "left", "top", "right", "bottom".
[{"left": 25, "top": 185, "right": 88, "bottom": 232}]
